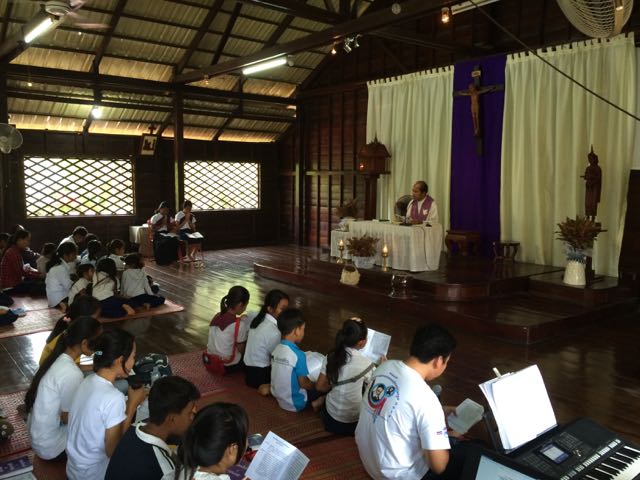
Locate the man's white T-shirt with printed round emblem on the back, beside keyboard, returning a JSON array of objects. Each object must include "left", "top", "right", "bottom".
[{"left": 356, "top": 360, "right": 450, "bottom": 480}]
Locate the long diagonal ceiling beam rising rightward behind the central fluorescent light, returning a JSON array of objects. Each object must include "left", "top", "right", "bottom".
[{"left": 176, "top": 0, "right": 448, "bottom": 83}]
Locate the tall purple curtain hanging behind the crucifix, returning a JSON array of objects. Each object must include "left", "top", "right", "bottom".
[{"left": 451, "top": 55, "right": 507, "bottom": 255}]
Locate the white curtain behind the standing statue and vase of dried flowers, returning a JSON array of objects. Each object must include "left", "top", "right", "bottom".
[{"left": 501, "top": 36, "right": 637, "bottom": 276}]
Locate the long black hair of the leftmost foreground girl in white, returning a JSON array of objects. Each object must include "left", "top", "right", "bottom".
[{"left": 24, "top": 316, "right": 102, "bottom": 413}]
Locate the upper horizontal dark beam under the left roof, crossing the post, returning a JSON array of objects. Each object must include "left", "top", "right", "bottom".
[{"left": 6, "top": 64, "right": 295, "bottom": 105}]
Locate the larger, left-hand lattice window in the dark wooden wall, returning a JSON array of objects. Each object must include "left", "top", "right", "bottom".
[{"left": 24, "top": 157, "right": 134, "bottom": 217}]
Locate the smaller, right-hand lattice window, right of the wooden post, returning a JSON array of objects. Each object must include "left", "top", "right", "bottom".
[{"left": 184, "top": 162, "right": 260, "bottom": 210}]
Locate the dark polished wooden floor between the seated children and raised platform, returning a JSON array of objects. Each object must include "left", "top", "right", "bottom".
[{"left": 0, "top": 246, "right": 640, "bottom": 443}]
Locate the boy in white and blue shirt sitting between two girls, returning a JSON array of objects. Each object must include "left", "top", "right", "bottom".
[{"left": 271, "top": 308, "right": 324, "bottom": 412}]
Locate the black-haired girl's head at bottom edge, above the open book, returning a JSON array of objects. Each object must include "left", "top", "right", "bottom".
[{"left": 162, "top": 403, "right": 249, "bottom": 480}]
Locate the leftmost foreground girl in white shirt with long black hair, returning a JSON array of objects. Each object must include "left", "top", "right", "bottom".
[{"left": 24, "top": 316, "right": 102, "bottom": 462}]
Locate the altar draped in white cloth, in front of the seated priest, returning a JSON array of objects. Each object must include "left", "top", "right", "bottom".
[{"left": 331, "top": 221, "right": 444, "bottom": 272}]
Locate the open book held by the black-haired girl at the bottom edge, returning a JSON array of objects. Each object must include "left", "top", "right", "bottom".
[{"left": 246, "top": 432, "right": 309, "bottom": 480}]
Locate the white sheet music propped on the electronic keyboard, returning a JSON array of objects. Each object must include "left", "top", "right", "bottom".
[{"left": 480, "top": 365, "right": 557, "bottom": 452}]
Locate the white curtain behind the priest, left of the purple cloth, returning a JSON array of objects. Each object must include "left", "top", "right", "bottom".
[{"left": 367, "top": 68, "right": 453, "bottom": 229}]
